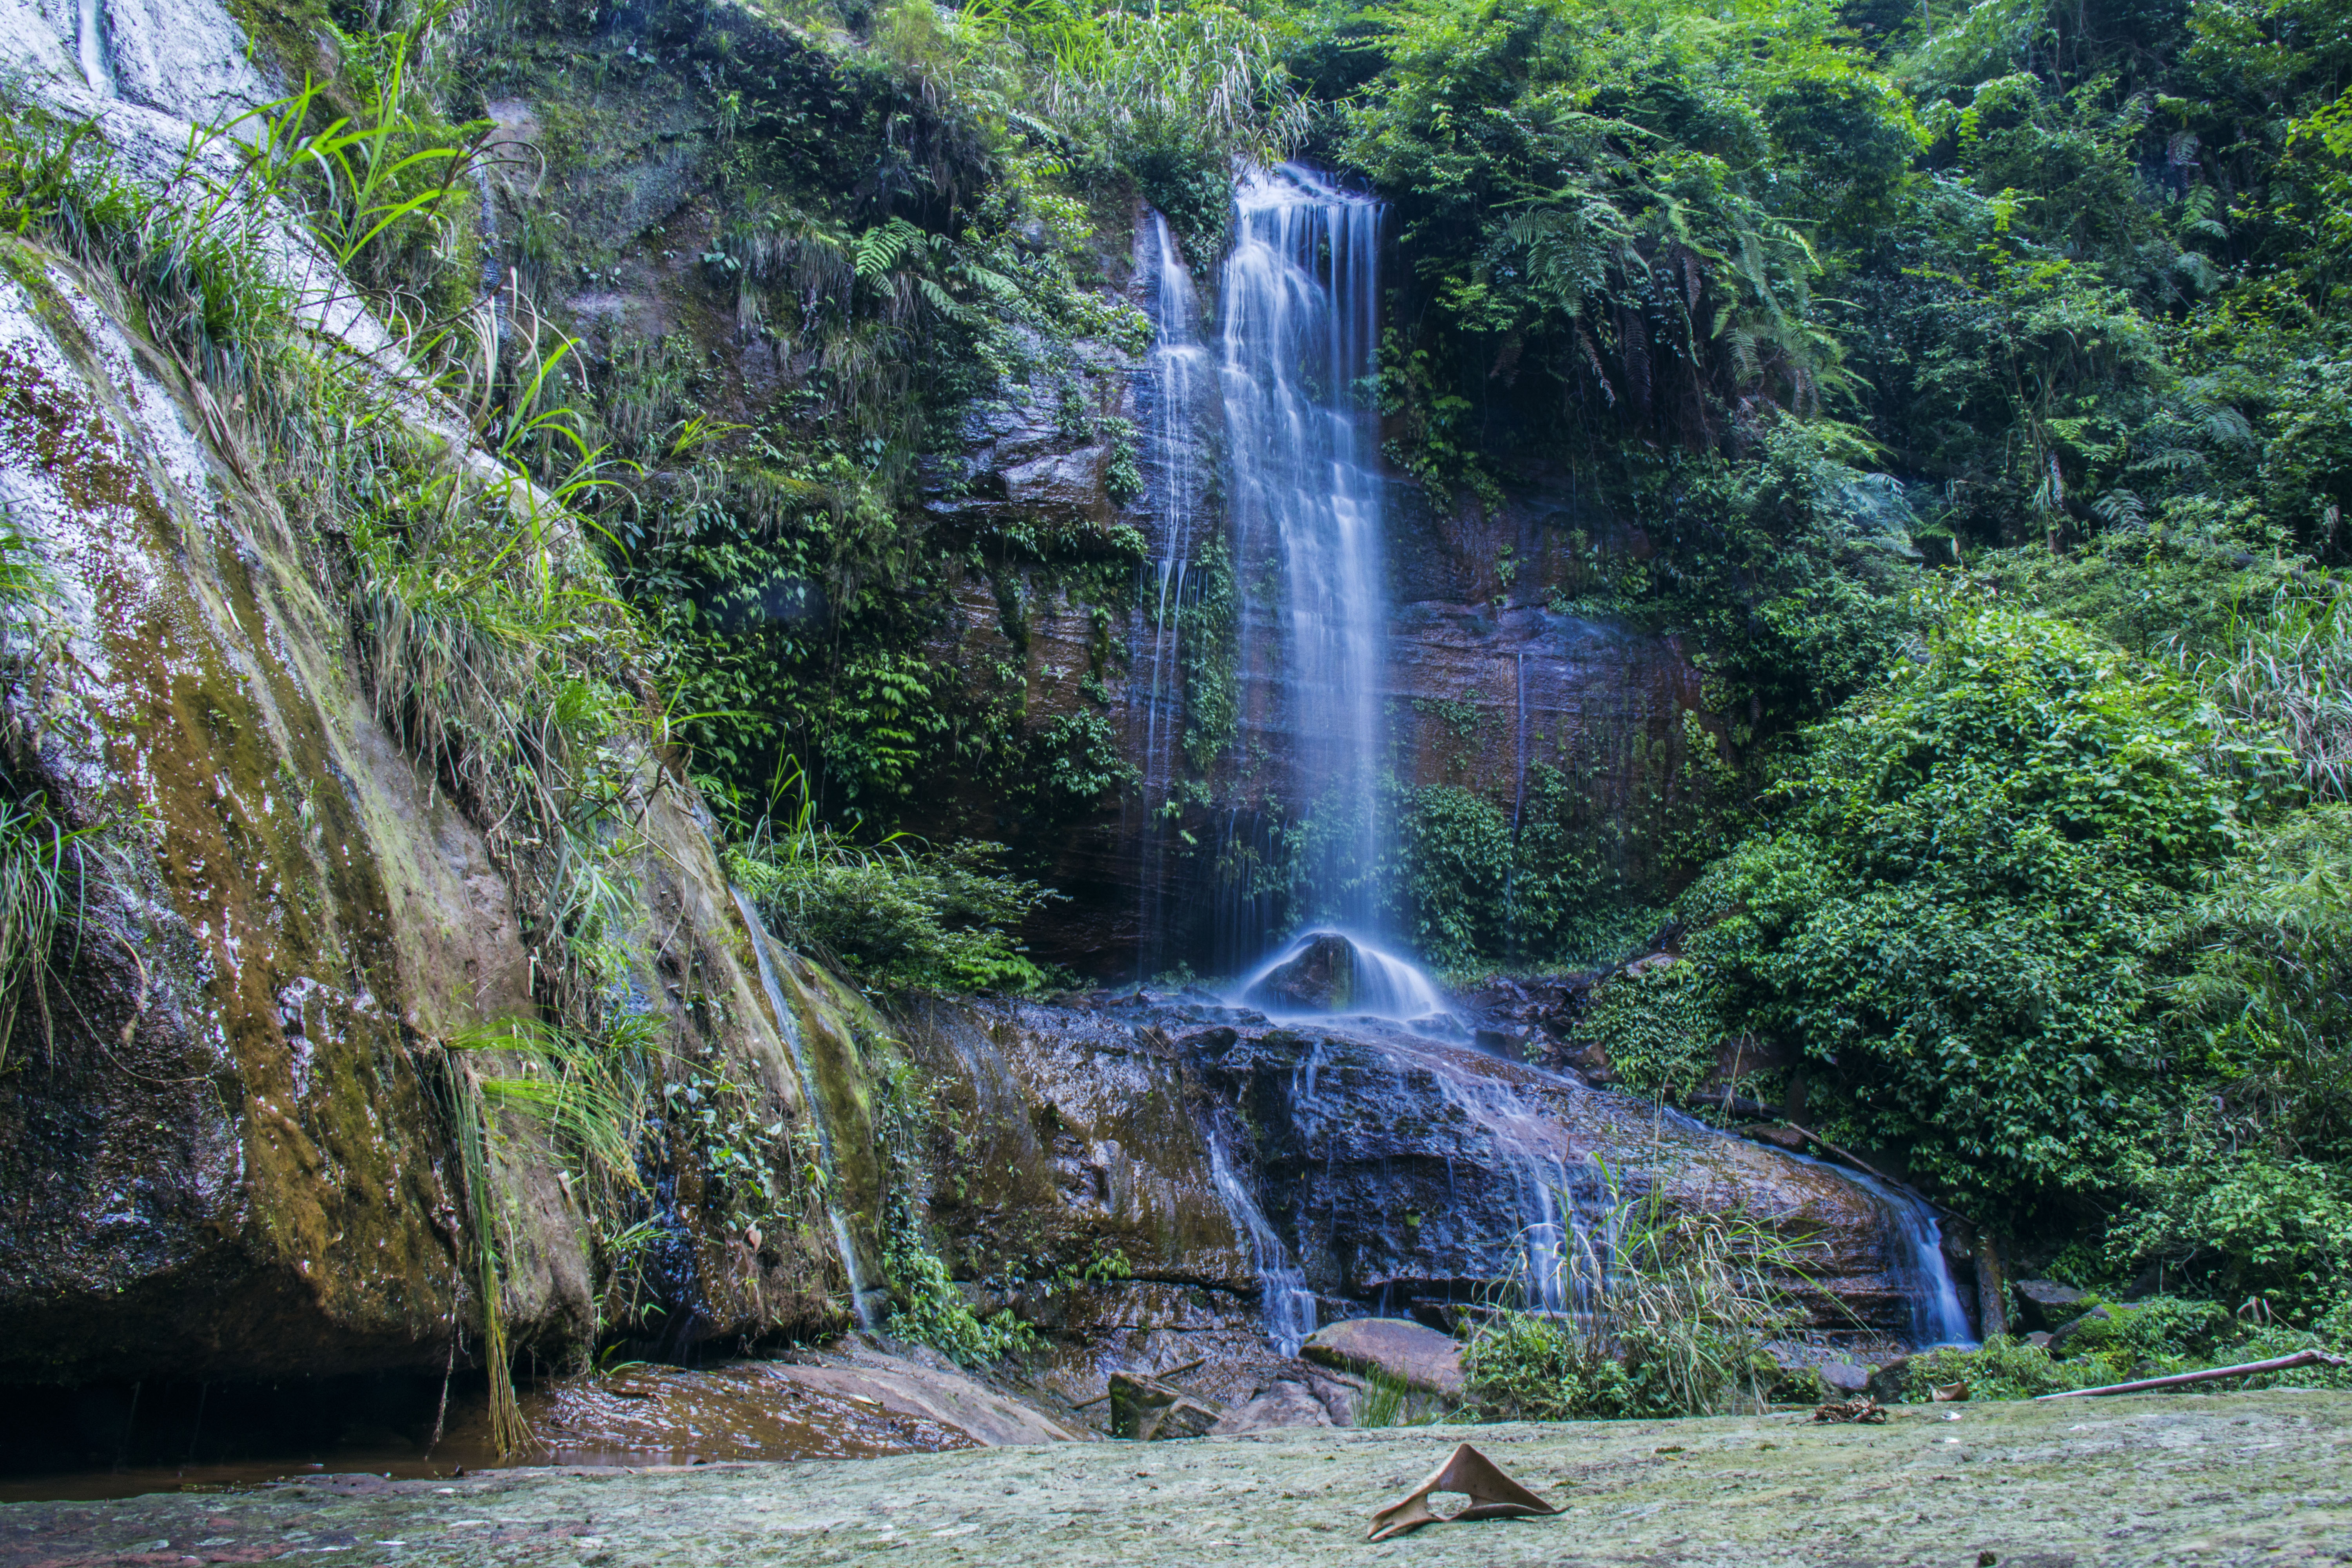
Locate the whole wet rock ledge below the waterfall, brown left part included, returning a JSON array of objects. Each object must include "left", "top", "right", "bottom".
[{"left": 910, "top": 997, "right": 1938, "bottom": 1382}]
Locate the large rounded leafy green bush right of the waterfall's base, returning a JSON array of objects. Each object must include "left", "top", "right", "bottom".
[{"left": 1611, "top": 597, "right": 2234, "bottom": 1194}]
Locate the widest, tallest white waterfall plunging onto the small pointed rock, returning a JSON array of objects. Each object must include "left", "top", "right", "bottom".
[{"left": 1218, "top": 165, "right": 1388, "bottom": 931}]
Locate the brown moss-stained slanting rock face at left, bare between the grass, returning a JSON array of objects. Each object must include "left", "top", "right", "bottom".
[{"left": 0, "top": 15, "right": 840, "bottom": 1382}]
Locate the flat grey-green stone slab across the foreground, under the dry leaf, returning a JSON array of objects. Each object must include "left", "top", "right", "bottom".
[{"left": 0, "top": 1389, "right": 2352, "bottom": 1568}]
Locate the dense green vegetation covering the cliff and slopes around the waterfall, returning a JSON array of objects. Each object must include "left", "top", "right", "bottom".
[{"left": 0, "top": 0, "right": 2352, "bottom": 1363}]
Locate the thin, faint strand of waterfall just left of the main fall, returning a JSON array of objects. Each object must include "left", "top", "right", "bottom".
[{"left": 1129, "top": 212, "right": 1209, "bottom": 980}]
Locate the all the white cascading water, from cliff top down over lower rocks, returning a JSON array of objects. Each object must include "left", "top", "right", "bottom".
[{"left": 1185, "top": 165, "right": 1966, "bottom": 1349}]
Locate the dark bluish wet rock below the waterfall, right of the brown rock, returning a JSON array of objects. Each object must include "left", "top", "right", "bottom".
[{"left": 1178, "top": 1020, "right": 1910, "bottom": 1330}]
